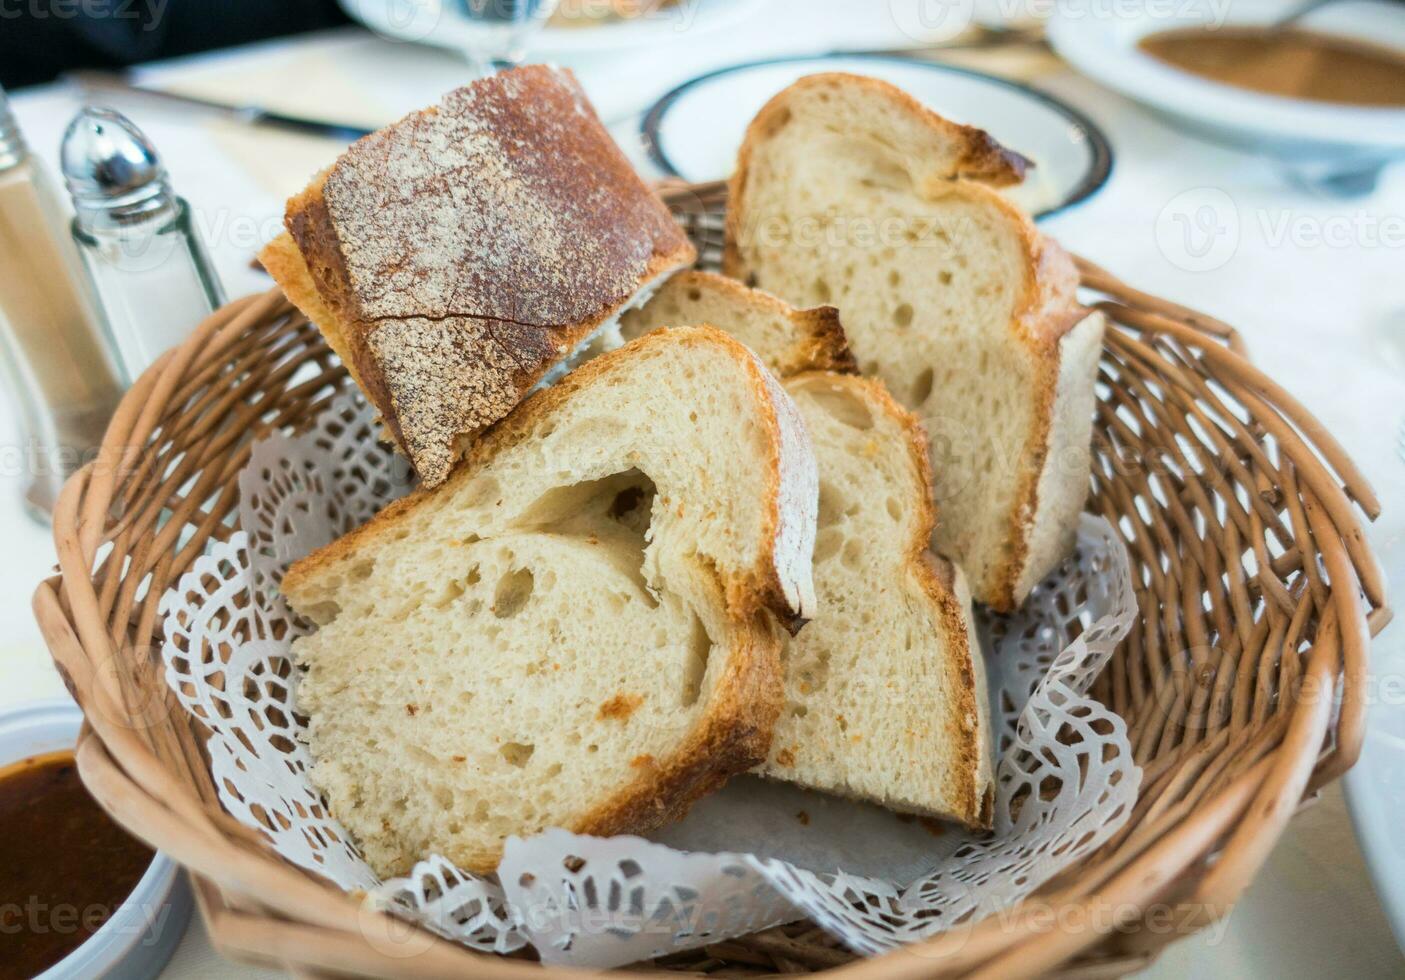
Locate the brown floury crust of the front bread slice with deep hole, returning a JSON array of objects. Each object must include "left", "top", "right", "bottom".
[{"left": 281, "top": 326, "right": 818, "bottom": 873}]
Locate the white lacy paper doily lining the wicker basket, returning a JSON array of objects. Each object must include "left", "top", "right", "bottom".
[{"left": 162, "top": 392, "right": 1141, "bottom": 967}]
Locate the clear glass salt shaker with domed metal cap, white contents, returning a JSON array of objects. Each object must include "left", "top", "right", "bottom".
[{"left": 59, "top": 107, "right": 225, "bottom": 383}]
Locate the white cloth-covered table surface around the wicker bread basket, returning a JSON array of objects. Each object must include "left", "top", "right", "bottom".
[{"left": 0, "top": 0, "right": 1405, "bottom": 977}]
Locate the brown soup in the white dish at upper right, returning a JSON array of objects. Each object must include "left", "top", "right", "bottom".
[{"left": 1137, "top": 27, "right": 1405, "bottom": 108}]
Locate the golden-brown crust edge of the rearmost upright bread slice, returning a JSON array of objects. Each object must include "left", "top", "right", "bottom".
[{"left": 722, "top": 73, "right": 1087, "bottom": 612}]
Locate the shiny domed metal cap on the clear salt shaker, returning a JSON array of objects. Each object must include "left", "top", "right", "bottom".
[{"left": 59, "top": 105, "right": 176, "bottom": 229}]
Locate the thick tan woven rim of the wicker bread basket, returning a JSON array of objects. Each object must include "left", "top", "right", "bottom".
[{"left": 35, "top": 249, "right": 1390, "bottom": 977}]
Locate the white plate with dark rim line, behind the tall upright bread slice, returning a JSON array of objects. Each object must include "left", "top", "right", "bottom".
[{"left": 642, "top": 55, "right": 1113, "bottom": 216}]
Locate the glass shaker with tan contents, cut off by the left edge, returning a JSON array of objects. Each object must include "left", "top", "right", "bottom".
[{"left": 0, "top": 91, "right": 122, "bottom": 522}]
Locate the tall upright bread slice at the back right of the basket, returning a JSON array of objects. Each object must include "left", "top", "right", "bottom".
[{"left": 724, "top": 74, "right": 1103, "bottom": 611}]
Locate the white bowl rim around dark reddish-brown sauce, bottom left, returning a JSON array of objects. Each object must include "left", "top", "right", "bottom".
[{"left": 0, "top": 698, "right": 191, "bottom": 980}]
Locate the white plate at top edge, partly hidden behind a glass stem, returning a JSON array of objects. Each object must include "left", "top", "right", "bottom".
[{"left": 340, "top": 0, "right": 763, "bottom": 60}]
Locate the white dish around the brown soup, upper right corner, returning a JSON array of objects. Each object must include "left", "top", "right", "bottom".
[{"left": 1048, "top": 0, "right": 1405, "bottom": 181}]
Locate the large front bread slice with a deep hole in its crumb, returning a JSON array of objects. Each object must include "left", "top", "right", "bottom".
[{"left": 282, "top": 329, "right": 818, "bottom": 875}]
